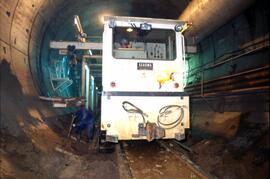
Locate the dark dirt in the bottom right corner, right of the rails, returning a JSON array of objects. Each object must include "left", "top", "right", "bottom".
[{"left": 186, "top": 133, "right": 269, "bottom": 179}]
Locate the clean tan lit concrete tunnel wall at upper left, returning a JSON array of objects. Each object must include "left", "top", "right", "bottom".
[{"left": 0, "top": 0, "right": 65, "bottom": 94}]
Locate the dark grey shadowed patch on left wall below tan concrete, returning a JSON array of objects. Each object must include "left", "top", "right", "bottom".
[{"left": 0, "top": 59, "right": 39, "bottom": 137}]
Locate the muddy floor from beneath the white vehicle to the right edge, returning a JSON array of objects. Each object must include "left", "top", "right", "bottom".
[{"left": 119, "top": 132, "right": 269, "bottom": 179}]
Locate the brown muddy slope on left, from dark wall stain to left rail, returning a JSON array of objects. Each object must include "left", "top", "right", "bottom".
[{"left": 0, "top": 60, "right": 119, "bottom": 179}]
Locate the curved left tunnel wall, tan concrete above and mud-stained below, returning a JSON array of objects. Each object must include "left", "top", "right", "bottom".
[{"left": 0, "top": 0, "right": 68, "bottom": 148}]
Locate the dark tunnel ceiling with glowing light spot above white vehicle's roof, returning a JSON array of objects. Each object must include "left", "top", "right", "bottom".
[{"left": 51, "top": 0, "right": 188, "bottom": 39}]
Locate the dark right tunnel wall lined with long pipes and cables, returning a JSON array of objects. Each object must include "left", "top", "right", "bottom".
[{"left": 186, "top": 1, "right": 269, "bottom": 145}]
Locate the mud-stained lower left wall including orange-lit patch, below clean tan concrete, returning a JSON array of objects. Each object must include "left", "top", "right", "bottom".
[{"left": 0, "top": 59, "right": 66, "bottom": 150}]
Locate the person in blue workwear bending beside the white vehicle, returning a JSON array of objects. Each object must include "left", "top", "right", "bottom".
[{"left": 73, "top": 103, "right": 94, "bottom": 143}]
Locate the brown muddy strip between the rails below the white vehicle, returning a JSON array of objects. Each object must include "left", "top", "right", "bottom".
[{"left": 123, "top": 141, "right": 208, "bottom": 179}]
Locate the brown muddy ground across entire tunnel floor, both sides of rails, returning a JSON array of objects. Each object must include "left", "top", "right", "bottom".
[{"left": 0, "top": 116, "right": 269, "bottom": 179}]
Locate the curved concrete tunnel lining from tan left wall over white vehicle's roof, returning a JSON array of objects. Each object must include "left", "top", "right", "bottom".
[{"left": 0, "top": 0, "right": 189, "bottom": 100}]
